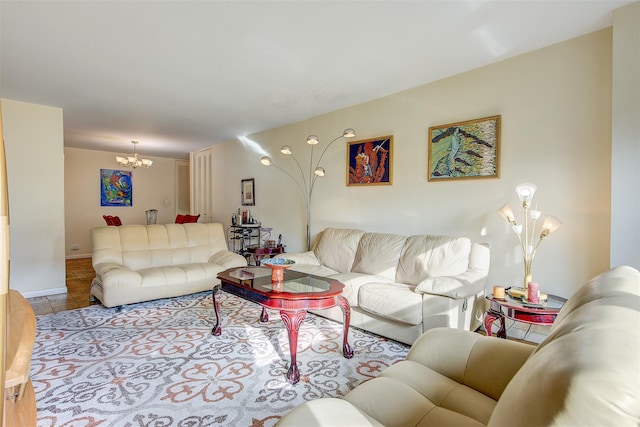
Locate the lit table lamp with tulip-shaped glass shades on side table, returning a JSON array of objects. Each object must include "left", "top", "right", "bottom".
[{"left": 498, "top": 182, "right": 562, "bottom": 295}]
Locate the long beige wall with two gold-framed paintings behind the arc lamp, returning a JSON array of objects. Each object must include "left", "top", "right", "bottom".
[{"left": 208, "top": 28, "right": 612, "bottom": 296}]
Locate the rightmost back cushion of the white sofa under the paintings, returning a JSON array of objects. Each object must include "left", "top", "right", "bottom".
[{"left": 396, "top": 235, "right": 471, "bottom": 285}]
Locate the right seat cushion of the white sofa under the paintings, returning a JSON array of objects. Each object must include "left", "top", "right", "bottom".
[{"left": 358, "top": 283, "right": 422, "bottom": 325}]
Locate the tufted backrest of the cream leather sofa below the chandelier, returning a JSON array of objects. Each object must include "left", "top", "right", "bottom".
[{"left": 90, "top": 223, "right": 227, "bottom": 270}]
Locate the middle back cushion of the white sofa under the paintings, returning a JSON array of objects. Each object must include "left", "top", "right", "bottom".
[{"left": 351, "top": 233, "right": 406, "bottom": 280}]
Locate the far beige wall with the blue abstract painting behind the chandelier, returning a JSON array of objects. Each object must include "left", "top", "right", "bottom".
[{"left": 64, "top": 148, "right": 182, "bottom": 258}]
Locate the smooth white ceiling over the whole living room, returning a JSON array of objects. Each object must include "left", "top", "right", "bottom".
[{"left": 0, "top": 0, "right": 633, "bottom": 158}]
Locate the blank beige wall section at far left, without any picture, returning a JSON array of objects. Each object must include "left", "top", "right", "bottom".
[{"left": 2, "top": 99, "right": 66, "bottom": 296}]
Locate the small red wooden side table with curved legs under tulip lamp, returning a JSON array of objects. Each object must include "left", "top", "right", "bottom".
[{"left": 484, "top": 293, "right": 567, "bottom": 338}]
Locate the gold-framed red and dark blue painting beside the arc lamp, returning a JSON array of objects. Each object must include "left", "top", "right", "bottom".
[{"left": 347, "top": 135, "right": 393, "bottom": 186}]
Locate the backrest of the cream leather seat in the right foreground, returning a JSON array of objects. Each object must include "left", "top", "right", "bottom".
[{"left": 489, "top": 266, "right": 640, "bottom": 426}]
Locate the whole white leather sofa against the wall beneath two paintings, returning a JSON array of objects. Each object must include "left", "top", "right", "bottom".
[{"left": 278, "top": 228, "right": 489, "bottom": 344}]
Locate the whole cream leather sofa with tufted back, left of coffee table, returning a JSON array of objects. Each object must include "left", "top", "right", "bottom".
[{"left": 90, "top": 223, "right": 247, "bottom": 307}]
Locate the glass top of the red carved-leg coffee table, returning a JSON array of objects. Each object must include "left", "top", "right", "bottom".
[{"left": 221, "top": 267, "right": 342, "bottom": 294}]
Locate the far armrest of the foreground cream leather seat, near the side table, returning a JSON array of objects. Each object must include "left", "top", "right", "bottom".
[{"left": 407, "top": 328, "right": 536, "bottom": 400}]
